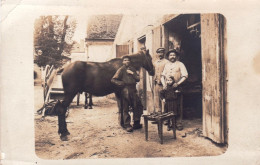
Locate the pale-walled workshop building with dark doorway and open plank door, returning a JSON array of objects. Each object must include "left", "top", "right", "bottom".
[{"left": 112, "top": 14, "right": 228, "bottom": 143}]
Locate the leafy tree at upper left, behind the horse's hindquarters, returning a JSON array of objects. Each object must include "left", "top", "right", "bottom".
[{"left": 34, "top": 16, "right": 77, "bottom": 68}]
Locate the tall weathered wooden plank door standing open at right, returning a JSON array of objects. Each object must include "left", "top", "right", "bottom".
[{"left": 201, "top": 14, "right": 226, "bottom": 143}]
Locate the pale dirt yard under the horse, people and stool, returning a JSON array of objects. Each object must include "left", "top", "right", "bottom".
[{"left": 34, "top": 86, "right": 227, "bottom": 159}]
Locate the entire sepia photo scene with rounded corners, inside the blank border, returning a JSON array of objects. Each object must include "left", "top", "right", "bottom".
[{"left": 33, "top": 13, "right": 229, "bottom": 160}]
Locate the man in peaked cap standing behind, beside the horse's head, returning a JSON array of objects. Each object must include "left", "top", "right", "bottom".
[{"left": 154, "top": 48, "right": 168, "bottom": 112}]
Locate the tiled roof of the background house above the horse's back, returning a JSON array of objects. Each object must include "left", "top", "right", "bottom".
[{"left": 86, "top": 15, "right": 122, "bottom": 39}]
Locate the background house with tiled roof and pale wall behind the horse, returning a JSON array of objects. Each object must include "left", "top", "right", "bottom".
[{"left": 85, "top": 15, "right": 122, "bottom": 62}]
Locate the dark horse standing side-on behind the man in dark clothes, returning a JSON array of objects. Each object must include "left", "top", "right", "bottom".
[{"left": 54, "top": 50, "right": 155, "bottom": 141}]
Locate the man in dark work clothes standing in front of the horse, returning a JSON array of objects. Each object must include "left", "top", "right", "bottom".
[{"left": 111, "top": 56, "right": 143, "bottom": 132}]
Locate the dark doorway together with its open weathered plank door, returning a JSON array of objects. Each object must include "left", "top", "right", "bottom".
[{"left": 163, "top": 14, "right": 228, "bottom": 143}]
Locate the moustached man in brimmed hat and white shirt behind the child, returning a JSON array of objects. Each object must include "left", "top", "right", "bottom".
[{"left": 161, "top": 50, "right": 188, "bottom": 130}]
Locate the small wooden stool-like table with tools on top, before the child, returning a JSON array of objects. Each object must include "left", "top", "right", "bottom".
[{"left": 143, "top": 112, "right": 176, "bottom": 144}]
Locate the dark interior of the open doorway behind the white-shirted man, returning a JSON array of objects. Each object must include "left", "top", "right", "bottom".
[{"left": 164, "top": 14, "right": 202, "bottom": 119}]
